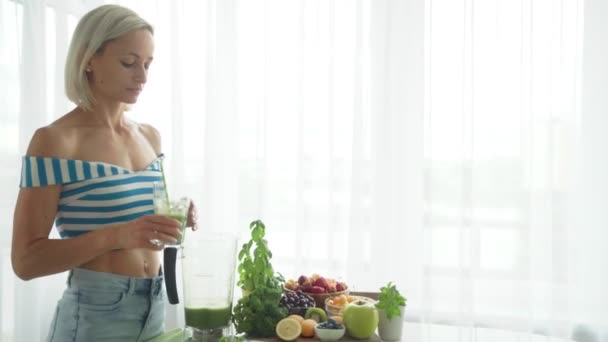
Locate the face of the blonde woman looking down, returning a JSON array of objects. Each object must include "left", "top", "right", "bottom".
[{"left": 89, "top": 30, "right": 154, "bottom": 104}]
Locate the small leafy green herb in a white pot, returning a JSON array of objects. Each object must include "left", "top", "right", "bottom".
[{"left": 376, "top": 282, "right": 406, "bottom": 341}]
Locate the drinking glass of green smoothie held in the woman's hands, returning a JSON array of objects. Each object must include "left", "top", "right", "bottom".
[{"left": 153, "top": 182, "right": 190, "bottom": 246}]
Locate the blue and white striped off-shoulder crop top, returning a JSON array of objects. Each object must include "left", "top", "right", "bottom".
[{"left": 20, "top": 155, "right": 162, "bottom": 238}]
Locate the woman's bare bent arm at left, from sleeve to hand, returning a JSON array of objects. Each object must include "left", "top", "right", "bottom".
[{"left": 11, "top": 186, "right": 180, "bottom": 280}]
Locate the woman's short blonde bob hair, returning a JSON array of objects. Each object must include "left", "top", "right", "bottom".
[{"left": 65, "top": 5, "right": 154, "bottom": 111}]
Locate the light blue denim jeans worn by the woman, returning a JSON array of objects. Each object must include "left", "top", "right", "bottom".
[{"left": 47, "top": 268, "right": 165, "bottom": 342}]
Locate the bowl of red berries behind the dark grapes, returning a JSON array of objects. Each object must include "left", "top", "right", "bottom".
[{"left": 285, "top": 273, "right": 350, "bottom": 309}]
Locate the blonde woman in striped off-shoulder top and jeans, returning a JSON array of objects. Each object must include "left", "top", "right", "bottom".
[{"left": 11, "top": 5, "right": 195, "bottom": 341}]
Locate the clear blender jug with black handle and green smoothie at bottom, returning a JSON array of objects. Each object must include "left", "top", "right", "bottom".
[{"left": 164, "top": 232, "right": 237, "bottom": 342}]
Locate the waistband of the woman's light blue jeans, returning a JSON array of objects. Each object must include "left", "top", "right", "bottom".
[{"left": 68, "top": 268, "right": 163, "bottom": 295}]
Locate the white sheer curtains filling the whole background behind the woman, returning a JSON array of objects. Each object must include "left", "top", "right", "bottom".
[{"left": 0, "top": 0, "right": 608, "bottom": 341}]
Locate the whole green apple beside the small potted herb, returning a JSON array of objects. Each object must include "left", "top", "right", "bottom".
[{"left": 342, "top": 300, "right": 379, "bottom": 339}]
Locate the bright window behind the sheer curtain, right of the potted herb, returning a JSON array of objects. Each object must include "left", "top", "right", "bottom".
[{"left": 425, "top": 0, "right": 582, "bottom": 333}]
